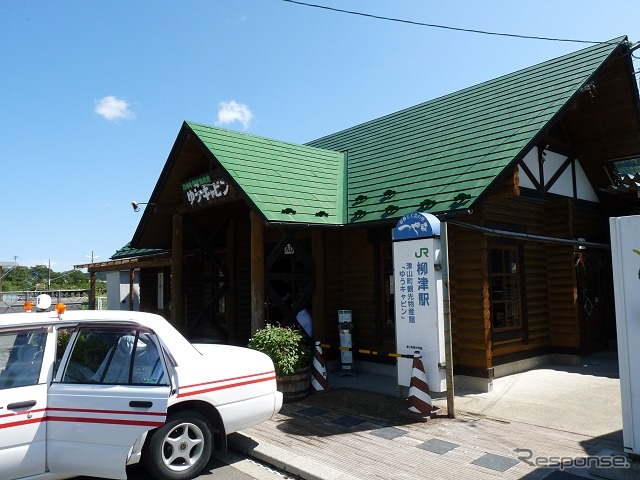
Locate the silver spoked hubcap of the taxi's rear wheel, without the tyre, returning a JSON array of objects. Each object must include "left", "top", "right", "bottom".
[{"left": 162, "top": 423, "right": 204, "bottom": 472}]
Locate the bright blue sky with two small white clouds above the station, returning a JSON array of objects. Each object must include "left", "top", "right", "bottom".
[{"left": 0, "top": 0, "right": 640, "bottom": 271}]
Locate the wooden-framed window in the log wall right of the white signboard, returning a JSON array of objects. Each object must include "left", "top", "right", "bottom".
[{"left": 489, "top": 246, "right": 523, "bottom": 332}]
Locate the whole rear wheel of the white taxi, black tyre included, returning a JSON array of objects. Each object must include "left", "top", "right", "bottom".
[{"left": 142, "top": 411, "right": 213, "bottom": 480}]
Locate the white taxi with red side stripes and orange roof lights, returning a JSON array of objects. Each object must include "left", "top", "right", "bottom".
[{"left": 0, "top": 299, "right": 282, "bottom": 480}]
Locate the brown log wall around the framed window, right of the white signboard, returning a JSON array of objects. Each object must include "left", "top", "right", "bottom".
[{"left": 449, "top": 170, "right": 604, "bottom": 368}]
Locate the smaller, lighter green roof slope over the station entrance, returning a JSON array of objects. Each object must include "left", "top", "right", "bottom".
[{"left": 187, "top": 122, "right": 345, "bottom": 225}]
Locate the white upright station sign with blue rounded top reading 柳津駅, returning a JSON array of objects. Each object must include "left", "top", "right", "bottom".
[{"left": 393, "top": 212, "right": 446, "bottom": 392}]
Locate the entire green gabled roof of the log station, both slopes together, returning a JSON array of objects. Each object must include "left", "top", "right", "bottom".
[{"left": 131, "top": 37, "right": 638, "bottom": 248}]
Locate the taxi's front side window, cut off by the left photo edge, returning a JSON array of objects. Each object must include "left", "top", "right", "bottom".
[{"left": 0, "top": 329, "right": 47, "bottom": 390}]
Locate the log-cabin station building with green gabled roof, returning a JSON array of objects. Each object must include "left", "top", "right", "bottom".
[{"left": 81, "top": 37, "right": 640, "bottom": 390}]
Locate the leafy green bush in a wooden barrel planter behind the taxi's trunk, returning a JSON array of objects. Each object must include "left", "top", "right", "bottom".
[{"left": 249, "top": 324, "right": 311, "bottom": 401}]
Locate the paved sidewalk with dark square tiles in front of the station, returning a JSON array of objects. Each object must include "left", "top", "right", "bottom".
[{"left": 230, "top": 350, "right": 640, "bottom": 480}]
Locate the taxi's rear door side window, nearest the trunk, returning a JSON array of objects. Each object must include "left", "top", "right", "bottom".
[{"left": 62, "top": 327, "right": 167, "bottom": 385}]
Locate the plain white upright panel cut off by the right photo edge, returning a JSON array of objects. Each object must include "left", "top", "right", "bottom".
[{"left": 609, "top": 216, "right": 640, "bottom": 455}]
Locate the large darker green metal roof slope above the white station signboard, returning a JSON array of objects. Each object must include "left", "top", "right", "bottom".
[{"left": 308, "top": 37, "right": 626, "bottom": 223}]
